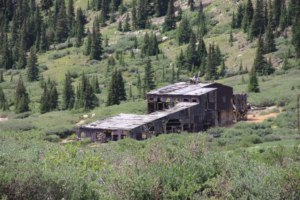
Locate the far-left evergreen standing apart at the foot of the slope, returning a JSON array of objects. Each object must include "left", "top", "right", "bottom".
[{"left": 14, "top": 80, "right": 30, "bottom": 114}]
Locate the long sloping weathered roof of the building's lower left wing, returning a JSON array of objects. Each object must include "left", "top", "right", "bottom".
[{"left": 81, "top": 102, "right": 198, "bottom": 130}]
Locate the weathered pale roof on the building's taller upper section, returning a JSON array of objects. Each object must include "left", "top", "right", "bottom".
[{"left": 148, "top": 82, "right": 217, "bottom": 96}]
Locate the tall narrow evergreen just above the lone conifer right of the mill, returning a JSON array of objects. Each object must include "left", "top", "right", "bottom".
[{"left": 253, "top": 35, "right": 266, "bottom": 74}]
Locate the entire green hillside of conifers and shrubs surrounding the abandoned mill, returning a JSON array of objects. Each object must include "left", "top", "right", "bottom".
[{"left": 0, "top": 0, "right": 300, "bottom": 200}]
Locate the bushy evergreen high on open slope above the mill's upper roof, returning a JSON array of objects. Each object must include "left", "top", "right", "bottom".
[{"left": 177, "top": 17, "right": 192, "bottom": 45}]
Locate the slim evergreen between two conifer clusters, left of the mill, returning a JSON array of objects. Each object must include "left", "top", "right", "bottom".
[{"left": 62, "top": 72, "right": 75, "bottom": 109}]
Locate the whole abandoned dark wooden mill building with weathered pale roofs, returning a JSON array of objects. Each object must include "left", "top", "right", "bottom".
[{"left": 77, "top": 81, "right": 247, "bottom": 143}]
